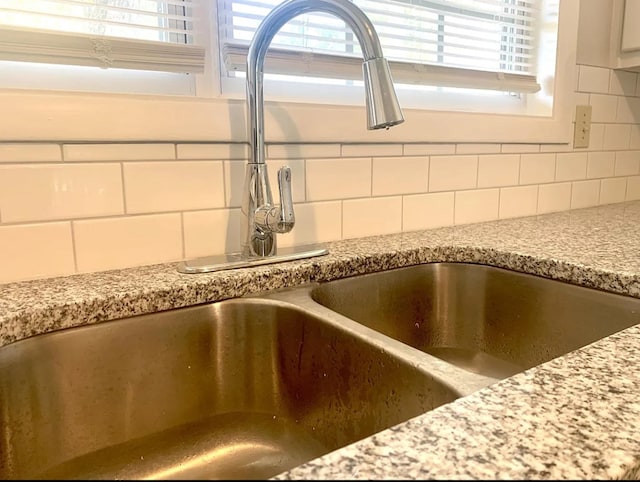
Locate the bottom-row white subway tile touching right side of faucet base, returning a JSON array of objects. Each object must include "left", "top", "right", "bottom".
[{"left": 278, "top": 201, "right": 342, "bottom": 247}]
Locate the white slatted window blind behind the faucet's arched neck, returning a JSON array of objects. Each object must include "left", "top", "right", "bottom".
[{"left": 218, "top": 0, "right": 542, "bottom": 93}]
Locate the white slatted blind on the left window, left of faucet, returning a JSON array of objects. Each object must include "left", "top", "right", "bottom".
[{"left": 0, "top": 0, "right": 205, "bottom": 73}]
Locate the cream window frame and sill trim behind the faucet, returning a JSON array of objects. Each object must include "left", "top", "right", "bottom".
[{"left": 0, "top": 0, "right": 579, "bottom": 144}]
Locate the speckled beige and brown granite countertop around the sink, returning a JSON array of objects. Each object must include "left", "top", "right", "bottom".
[{"left": 0, "top": 201, "right": 640, "bottom": 479}]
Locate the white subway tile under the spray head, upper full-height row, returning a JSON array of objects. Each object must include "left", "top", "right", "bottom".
[{"left": 373, "top": 157, "right": 429, "bottom": 196}]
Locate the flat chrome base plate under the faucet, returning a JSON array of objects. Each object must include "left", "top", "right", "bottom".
[{"left": 178, "top": 245, "right": 329, "bottom": 274}]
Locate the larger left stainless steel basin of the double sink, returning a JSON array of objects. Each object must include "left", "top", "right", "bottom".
[{"left": 0, "top": 299, "right": 460, "bottom": 479}]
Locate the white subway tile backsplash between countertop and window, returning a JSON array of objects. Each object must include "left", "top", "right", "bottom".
[{"left": 0, "top": 65, "right": 640, "bottom": 283}]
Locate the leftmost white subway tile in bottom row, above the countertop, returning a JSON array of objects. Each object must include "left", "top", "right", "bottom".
[{"left": 0, "top": 222, "right": 75, "bottom": 284}]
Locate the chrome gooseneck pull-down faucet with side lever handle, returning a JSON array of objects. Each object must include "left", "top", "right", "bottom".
[{"left": 242, "top": 0, "right": 404, "bottom": 257}]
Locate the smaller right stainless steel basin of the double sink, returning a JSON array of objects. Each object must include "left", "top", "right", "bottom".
[{"left": 311, "top": 263, "right": 640, "bottom": 379}]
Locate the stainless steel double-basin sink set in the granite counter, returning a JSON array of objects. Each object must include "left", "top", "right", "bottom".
[{"left": 0, "top": 263, "right": 640, "bottom": 479}]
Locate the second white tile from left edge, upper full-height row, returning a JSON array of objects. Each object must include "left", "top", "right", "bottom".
[{"left": 124, "top": 161, "right": 224, "bottom": 213}]
